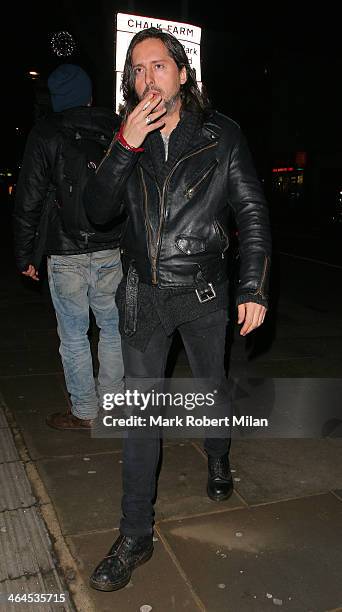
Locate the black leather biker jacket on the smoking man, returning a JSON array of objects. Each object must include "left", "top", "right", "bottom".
[{"left": 85, "top": 112, "right": 271, "bottom": 305}]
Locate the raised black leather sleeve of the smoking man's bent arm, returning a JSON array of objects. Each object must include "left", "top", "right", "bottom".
[{"left": 84, "top": 137, "right": 140, "bottom": 225}]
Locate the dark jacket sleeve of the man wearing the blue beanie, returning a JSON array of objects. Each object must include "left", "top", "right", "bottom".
[{"left": 13, "top": 128, "right": 50, "bottom": 271}]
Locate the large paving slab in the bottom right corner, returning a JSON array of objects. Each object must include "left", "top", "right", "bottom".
[{"left": 159, "top": 494, "right": 342, "bottom": 612}]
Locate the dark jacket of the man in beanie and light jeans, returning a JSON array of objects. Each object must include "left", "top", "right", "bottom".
[{"left": 13, "top": 107, "right": 121, "bottom": 271}]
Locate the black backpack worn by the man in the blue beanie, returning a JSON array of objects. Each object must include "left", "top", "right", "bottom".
[{"left": 55, "top": 127, "right": 113, "bottom": 245}]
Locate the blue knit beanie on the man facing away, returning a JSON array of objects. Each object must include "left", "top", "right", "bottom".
[{"left": 48, "top": 64, "right": 92, "bottom": 112}]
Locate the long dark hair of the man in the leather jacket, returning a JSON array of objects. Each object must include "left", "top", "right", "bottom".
[{"left": 120, "top": 28, "right": 210, "bottom": 120}]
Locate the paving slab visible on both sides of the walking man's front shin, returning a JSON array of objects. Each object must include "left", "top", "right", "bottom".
[{"left": 37, "top": 444, "right": 243, "bottom": 535}]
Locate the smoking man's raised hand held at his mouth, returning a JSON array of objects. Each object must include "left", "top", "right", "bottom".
[{"left": 122, "top": 94, "right": 166, "bottom": 149}]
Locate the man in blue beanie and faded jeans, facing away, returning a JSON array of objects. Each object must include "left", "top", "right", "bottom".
[{"left": 14, "top": 64, "right": 123, "bottom": 430}]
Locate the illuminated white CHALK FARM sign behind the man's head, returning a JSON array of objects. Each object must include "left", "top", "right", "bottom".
[{"left": 115, "top": 13, "right": 201, "bottom": 112}]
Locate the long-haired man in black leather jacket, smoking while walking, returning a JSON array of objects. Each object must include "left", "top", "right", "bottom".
[{"left": 85, "top": 28, "right": 271, "bottom": 591}]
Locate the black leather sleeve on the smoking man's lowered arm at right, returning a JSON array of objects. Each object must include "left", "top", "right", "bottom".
[{"left": 228, "top": 131, "right": 272, "bottom": 307}]
